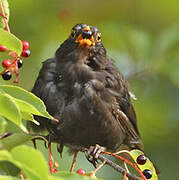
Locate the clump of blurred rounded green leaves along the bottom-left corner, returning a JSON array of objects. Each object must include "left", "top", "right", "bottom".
[{"left": 0, "top": 145, "right": 100, "bottom": 180}]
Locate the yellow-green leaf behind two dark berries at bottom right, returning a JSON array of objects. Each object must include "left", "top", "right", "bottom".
[{"left": 128, "top": 149, "right": 158, "bottom": 180}]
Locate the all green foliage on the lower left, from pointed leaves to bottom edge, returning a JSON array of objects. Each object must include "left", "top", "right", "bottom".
[{"left": 0, "top": 85, "right": 104, "bottom": 180}]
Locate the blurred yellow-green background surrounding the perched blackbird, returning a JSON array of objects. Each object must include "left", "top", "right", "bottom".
[{"left": 0, "top": 0, "right": 179, "bottom": 180}]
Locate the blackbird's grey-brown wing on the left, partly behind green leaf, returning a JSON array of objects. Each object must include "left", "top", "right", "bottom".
[{"left": 29, "top": 58, "right": 64, "bottom": 130}]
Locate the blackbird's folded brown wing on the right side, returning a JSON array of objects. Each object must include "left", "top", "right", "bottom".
[{"left": 106, "top": 63, "right": 141, "bottom": 148}]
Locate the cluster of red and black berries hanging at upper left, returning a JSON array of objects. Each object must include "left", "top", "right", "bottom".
[{"left": 0, "top": 41, "right": 30, "bottom": 83}]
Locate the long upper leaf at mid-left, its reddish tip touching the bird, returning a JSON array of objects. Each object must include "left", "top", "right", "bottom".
[{"left": 0, "top": 85, "right": 53, "bottom": 119}]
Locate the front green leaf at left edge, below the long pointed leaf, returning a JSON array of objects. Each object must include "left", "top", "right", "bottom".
[{"left": 0, "top": 93, "right": 21, "bottom": 130}]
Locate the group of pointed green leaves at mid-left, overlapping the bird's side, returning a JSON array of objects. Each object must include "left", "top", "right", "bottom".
[{"left": 0, "top": 85, "right": 53, "bottom": 132}]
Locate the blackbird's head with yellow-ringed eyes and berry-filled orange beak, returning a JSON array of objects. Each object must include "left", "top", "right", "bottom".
[{"left": 56, "top": 24, "right": 106, "bottom": 67}]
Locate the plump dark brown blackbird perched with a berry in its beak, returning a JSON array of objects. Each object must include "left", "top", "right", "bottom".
[{"left": 32, "top": 24, "right": 142, "bottom": 155}]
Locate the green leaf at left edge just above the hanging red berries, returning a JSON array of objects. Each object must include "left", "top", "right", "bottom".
[{"left": 0, "top": 29, "right": 22, "bottom": 56}]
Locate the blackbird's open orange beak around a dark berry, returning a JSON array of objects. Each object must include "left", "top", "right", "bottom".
[{"left": 75, "top": 26, "right": 95, "bottom": 47}]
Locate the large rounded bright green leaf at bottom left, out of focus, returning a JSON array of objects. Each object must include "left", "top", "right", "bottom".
[{"left": 11, "top": 146, "right": 49, "bottom": 180}]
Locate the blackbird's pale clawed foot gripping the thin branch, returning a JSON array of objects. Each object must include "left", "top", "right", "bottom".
[{"left": 85, "top": 144, "right": 105, "bottom": 168}]
